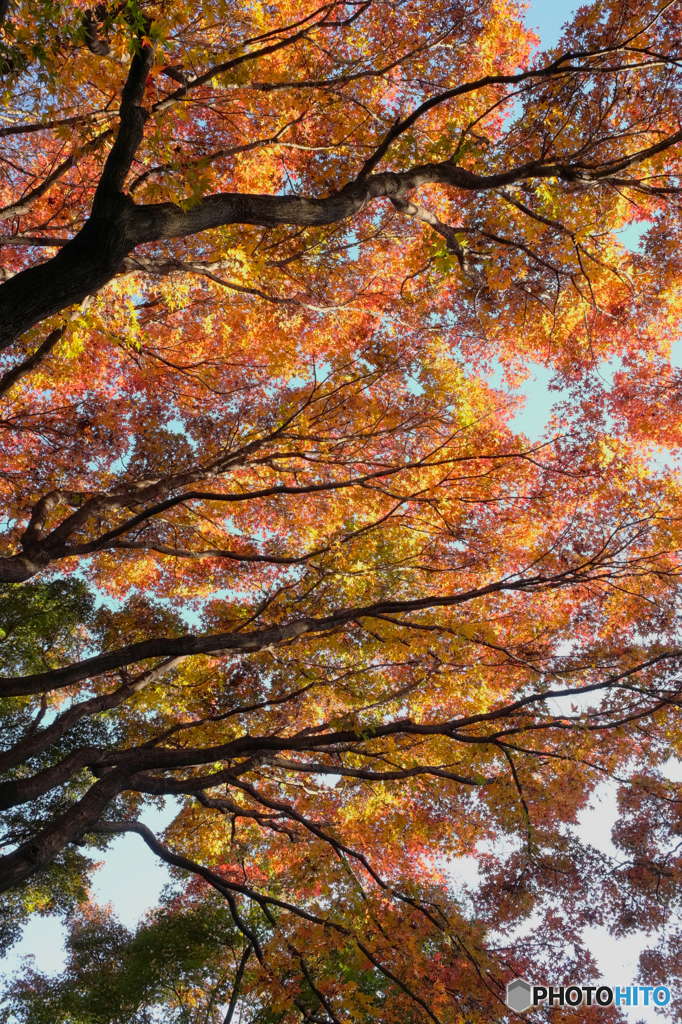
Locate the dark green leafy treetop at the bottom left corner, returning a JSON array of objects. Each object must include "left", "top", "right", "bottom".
[{"left": 4, "top": 892, "right": 260, "bottom": 1024}]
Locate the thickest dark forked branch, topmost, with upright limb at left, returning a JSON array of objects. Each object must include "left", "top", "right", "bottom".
[{"left": 0, "top": 37, "right": 682, "bottom": 349}]
